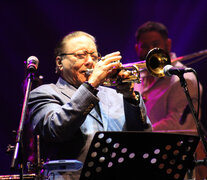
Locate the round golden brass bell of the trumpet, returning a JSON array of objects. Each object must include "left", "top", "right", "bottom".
[{"left": 146, "top": 48, "right": 171, "bottom": 77}]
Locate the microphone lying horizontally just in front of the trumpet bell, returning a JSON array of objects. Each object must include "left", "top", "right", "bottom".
[{"left": 163, "top": 64, "right": 194, "bottom": 76}]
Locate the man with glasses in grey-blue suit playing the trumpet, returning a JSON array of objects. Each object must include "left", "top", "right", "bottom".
[{"left": 29, "top": 31, "right": 151, "bottom": 179}]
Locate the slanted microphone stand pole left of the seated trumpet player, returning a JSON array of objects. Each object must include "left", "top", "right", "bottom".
[{"left": 11, "top": 72, "right": 34, "bottom": 180}]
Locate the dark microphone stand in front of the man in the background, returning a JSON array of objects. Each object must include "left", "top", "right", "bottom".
[{"left": 178, "top": 70, "right": 207, "bottom": 167}]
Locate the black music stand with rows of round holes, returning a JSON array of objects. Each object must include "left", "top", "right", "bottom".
[{"left": 80, "top": 132, "right": 199, "bottom": 180}]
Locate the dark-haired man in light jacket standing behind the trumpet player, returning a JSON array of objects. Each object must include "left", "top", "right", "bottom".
[{"left": 135, "top": 21, "right": 202, "bottom": 131}]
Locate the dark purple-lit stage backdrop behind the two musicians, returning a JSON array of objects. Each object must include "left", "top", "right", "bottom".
[{"left": 0, "top": 0, "right": 207, "bottom": 174}]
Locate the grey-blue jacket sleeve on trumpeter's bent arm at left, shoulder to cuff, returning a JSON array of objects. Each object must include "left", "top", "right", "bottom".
[{"left": 28, "top": 85, "right": 99, "bottom": 142}]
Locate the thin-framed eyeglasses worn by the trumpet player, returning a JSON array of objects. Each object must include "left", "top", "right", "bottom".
[{"left": 59, "top": 51, "right": 101, "bottom": 61}]
